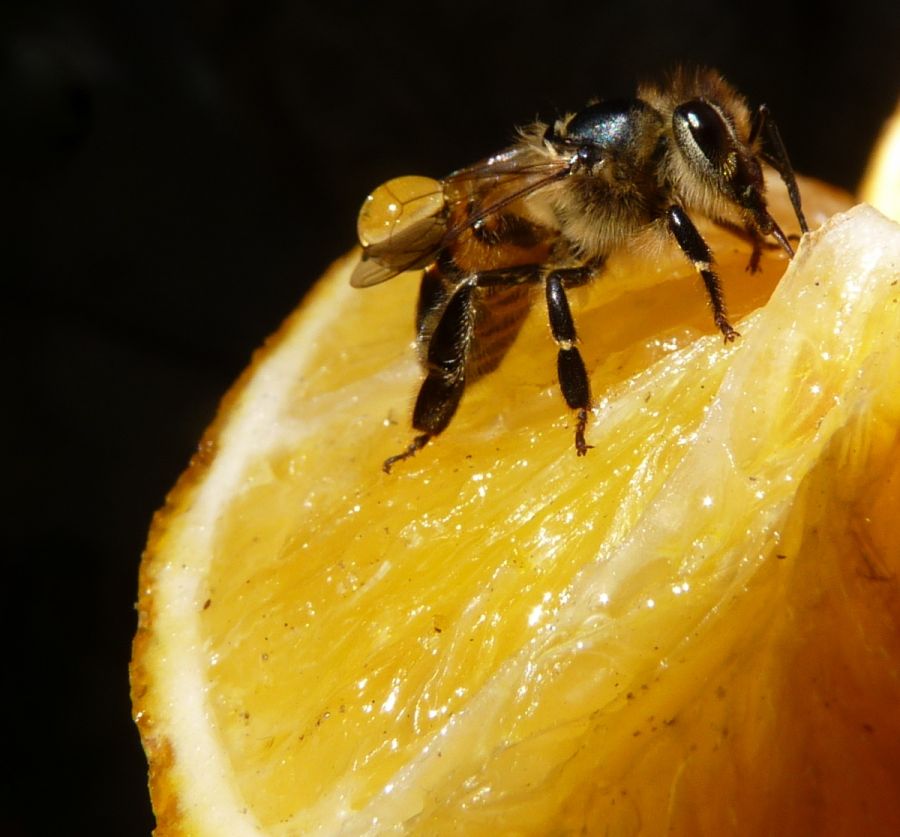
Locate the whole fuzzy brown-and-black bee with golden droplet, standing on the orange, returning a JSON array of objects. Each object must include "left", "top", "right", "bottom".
[{"left": 350, "top": 69, "right": 808, "bottom": 473}]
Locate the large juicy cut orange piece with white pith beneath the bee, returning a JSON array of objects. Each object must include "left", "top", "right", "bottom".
[{"left": 133, "top": 175, "right": 900, "bottom": 835}]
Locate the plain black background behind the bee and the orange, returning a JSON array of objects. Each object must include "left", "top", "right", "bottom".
[{"left": 0, "top": 0, "right": 900, "bottom": 835}]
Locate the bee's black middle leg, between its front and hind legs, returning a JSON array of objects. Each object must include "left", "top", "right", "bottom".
[{"left": 546, "top": 268, "right": 591, "bottom": 456}]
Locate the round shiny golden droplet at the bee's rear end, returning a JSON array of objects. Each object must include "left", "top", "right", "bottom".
[{"left": 356, "top": 176, "right": 444, "bottom": 247}]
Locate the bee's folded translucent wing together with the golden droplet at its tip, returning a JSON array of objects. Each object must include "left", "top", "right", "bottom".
[{"left": 350, "top": 146, "right": 571, "bottom": 288}]
